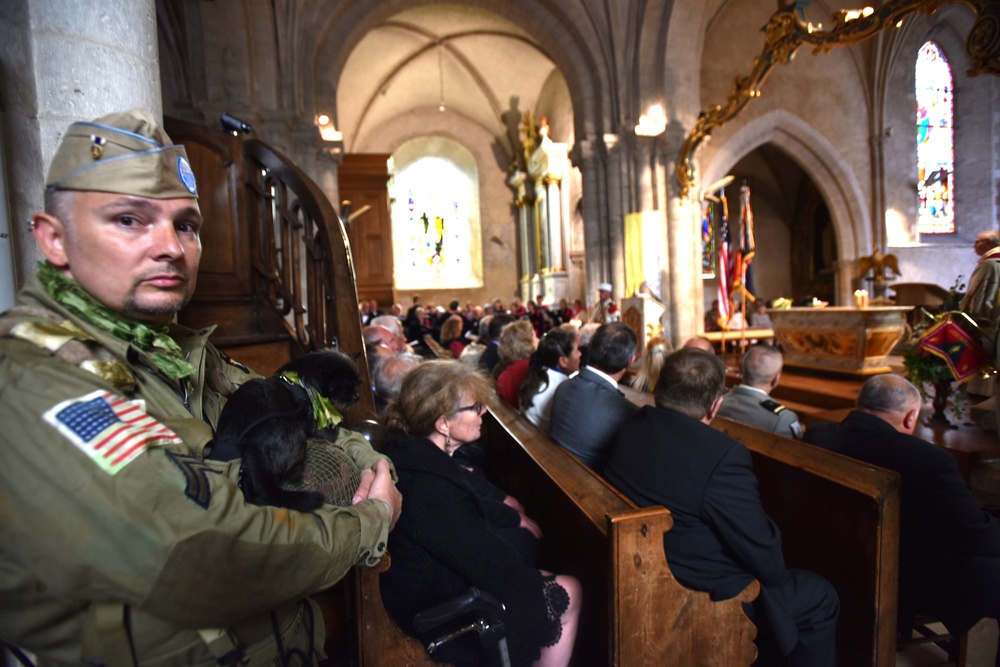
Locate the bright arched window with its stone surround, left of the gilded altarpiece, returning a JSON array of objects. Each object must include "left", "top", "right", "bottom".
[{"left": 389, "top": 137, "right": 482, "bottom": 289}]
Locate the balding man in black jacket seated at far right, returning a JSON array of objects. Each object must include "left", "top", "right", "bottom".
[{"left": 805, "top": 375, "right": 1000, "bottom": 636}]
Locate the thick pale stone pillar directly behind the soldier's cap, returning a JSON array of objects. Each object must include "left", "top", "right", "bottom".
[{"left": 0, "top": 0, "right": 163, "bottom": 285}]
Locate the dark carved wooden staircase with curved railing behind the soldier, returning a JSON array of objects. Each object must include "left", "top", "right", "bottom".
[{"left": 165, "top": 118, "right": 375, "bottom": 422}]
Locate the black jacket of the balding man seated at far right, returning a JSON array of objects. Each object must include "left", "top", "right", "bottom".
[{"left": 805, "top": 411, "right": 1000, "bottom": 632}]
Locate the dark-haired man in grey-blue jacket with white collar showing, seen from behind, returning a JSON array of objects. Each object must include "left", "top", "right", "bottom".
[{"left": 549, "top": 322, "right": 638, "bottom": 472}]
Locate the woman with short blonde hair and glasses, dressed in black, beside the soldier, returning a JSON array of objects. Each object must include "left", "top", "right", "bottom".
[{"left": 381, "top": 361, "right": 581, "bottom": 667}]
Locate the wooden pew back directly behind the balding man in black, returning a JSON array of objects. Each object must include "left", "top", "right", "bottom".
[{"left": 712, "top": 418, "right": 900, "bottom": 667}]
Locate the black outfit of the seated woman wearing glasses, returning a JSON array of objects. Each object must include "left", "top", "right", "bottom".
[{"left": 381, "top": 438, "right": 559, "bottom": 665}]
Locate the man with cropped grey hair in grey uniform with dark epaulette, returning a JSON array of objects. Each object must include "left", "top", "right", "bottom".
[{"left": 719, "top": 345, "right": 803, "bottom": 439}]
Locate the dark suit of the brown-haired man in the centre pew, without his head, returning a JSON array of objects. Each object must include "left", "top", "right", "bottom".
[{"left": 604, "top": 406, "right": 824, "bottom": 664}]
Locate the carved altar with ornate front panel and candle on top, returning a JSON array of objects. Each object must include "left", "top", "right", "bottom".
[{"left": 768, "top": 306, "right": 912, "bottom": 375}]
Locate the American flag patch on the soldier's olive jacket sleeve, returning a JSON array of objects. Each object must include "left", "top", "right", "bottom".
[{"left": 43, "top": 389, "right": 181, "bottom": 475}]
